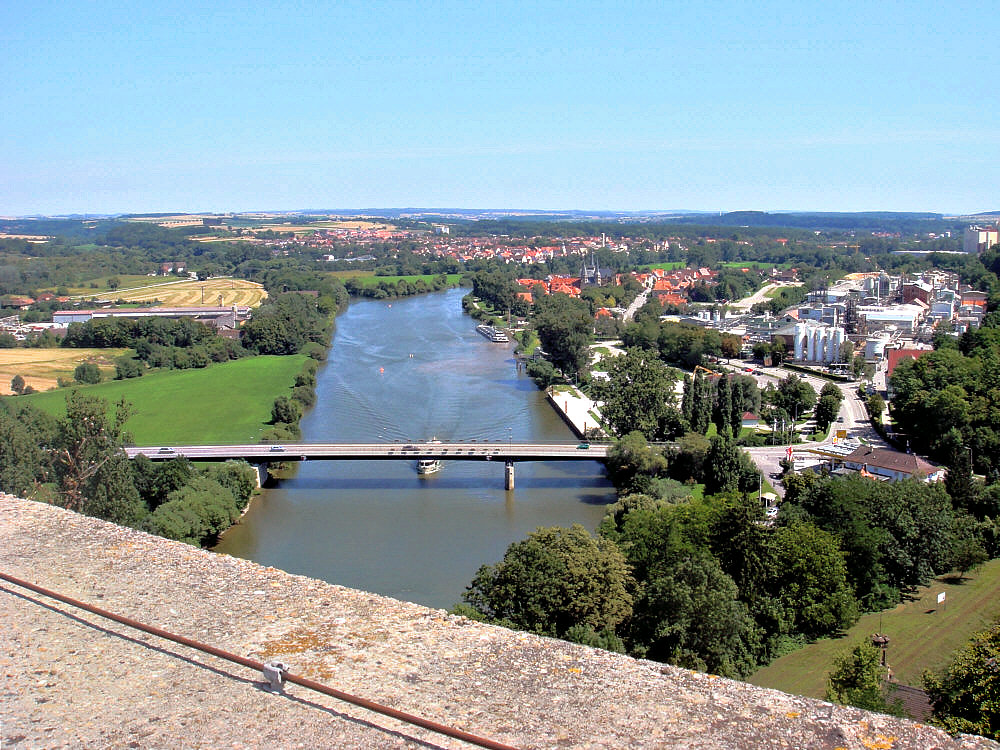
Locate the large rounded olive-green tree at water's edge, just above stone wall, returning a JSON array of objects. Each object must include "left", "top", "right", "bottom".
[{"left": 463, "top": 524, "right": 632, "bottom": 636}]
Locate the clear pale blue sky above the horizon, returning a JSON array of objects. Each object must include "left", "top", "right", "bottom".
[{"left": 0, "top": 0, "right": 1000, "bottom": 215}]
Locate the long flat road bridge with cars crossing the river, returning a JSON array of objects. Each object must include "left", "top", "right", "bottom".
[{"left": 125, "top": 440, "right": 611, "bottom": 490}]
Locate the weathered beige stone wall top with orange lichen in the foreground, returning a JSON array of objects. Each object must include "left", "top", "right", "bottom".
[{"left": 0, "top": 496, "right": 1000, "bottom": 749}]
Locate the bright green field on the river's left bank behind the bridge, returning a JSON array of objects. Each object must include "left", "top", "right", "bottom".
[{"left": 25, "top": 355, "right": 306, "bottom": 445}]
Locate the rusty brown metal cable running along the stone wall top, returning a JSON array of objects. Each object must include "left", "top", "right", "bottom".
[{"left": 0, "top": 572, "right": 517, "bottom": 750}]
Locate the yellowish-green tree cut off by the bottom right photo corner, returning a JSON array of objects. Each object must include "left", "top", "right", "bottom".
[{"left": 923, "top": 623, "right": 1000, "bottom": 740}]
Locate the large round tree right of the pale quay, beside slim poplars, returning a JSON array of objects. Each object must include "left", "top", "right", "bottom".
[{"left": 593, "top": 348, "right": 683, "bottom": 440}]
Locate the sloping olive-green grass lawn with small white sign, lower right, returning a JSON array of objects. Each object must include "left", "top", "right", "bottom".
[{"left": 748, "top": 560, "right": 1000, "bottom": 698}]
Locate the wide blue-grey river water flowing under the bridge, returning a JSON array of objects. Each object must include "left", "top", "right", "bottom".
[{"left": 215, "top": 289, "right": 615, "bottom": 608}]
